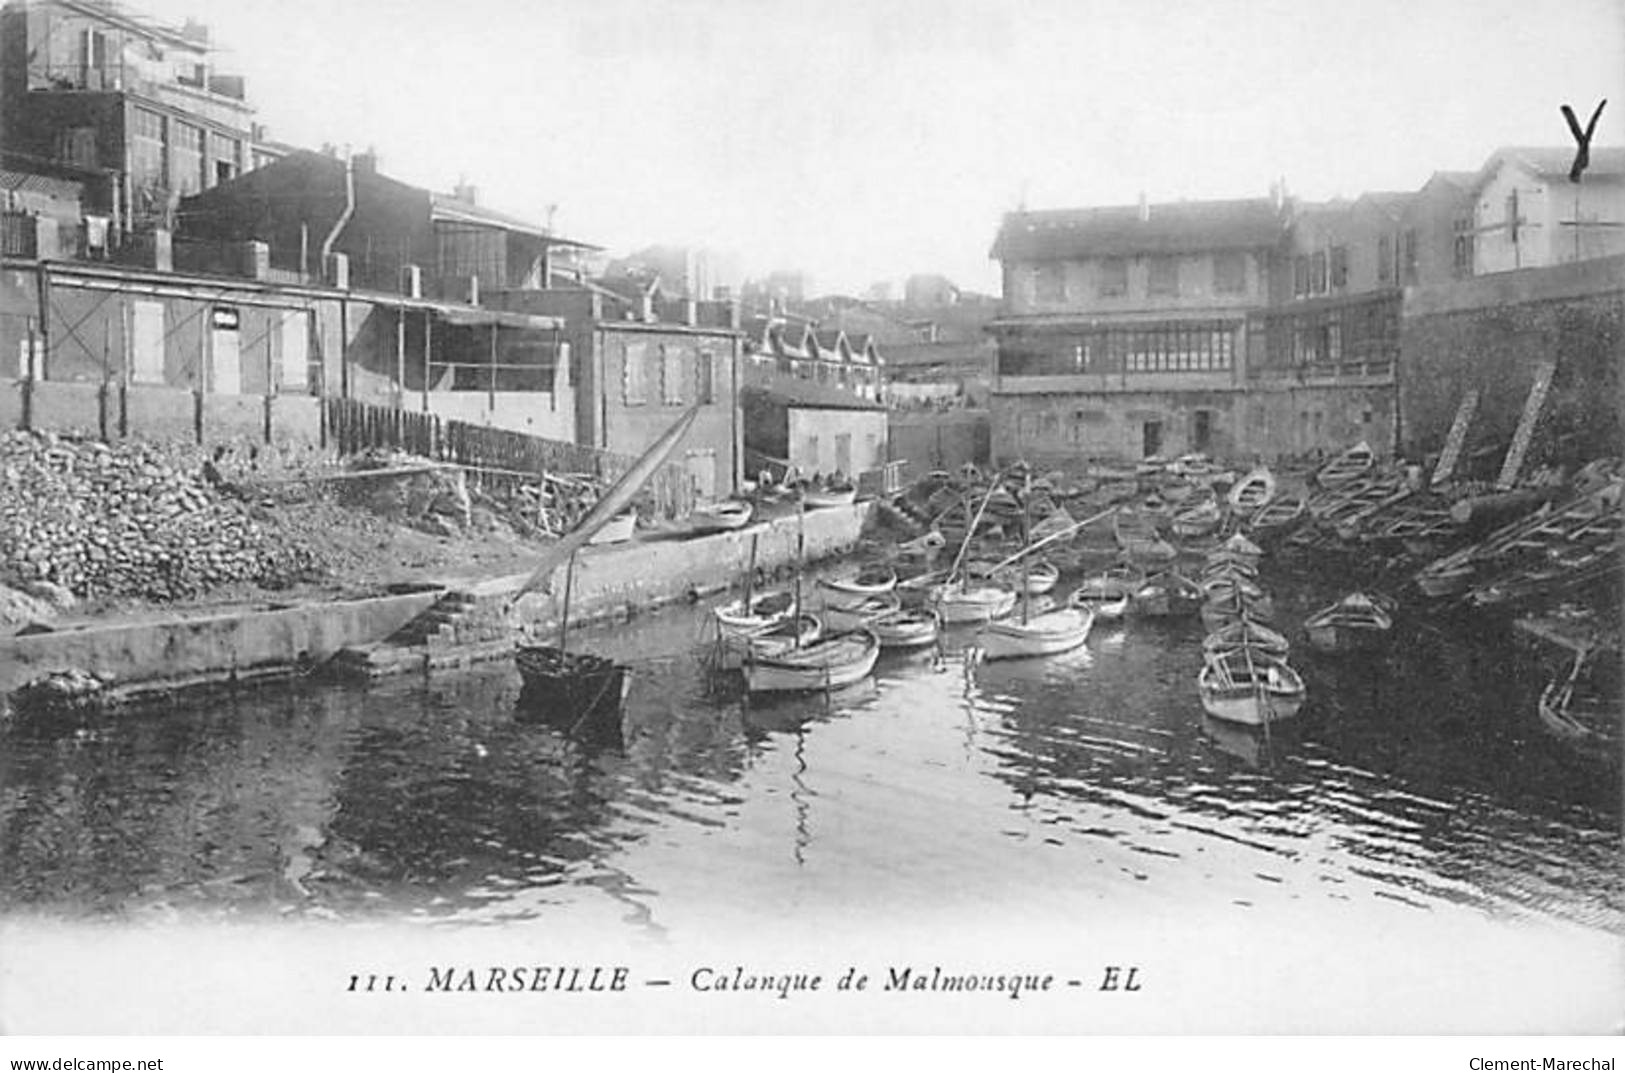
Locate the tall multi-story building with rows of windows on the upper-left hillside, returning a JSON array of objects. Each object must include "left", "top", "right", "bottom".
[{"left": 0, "top": 0, "right": 255, "bottom": 238}]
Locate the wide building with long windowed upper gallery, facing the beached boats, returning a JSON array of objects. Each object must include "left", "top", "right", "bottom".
[{"left": 990, "top": 197, "right": 1289, "bottom": 462}]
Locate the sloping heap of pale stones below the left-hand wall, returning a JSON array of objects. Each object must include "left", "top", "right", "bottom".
[{"left": 0, "top": 432, "right": 320, "bottom": 600}]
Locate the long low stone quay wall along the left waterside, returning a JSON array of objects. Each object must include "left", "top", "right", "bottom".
[{"left": 0, "top": 504, "right": 869, "bottom": 701}]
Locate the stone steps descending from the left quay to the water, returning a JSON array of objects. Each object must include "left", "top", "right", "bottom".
[{"left": 330, "top": 590, "right": 514, "bottom": 680}]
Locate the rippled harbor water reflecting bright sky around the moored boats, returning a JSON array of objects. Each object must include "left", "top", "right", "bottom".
[{"left": 0, "top": 552, "right": 1625, "bottom": 1020}]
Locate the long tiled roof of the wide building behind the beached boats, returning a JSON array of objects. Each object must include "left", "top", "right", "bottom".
[{"left": 993, "top": 198, "right": 1285, "bottom": 260}]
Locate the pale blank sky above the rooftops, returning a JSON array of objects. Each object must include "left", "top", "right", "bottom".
[{"left": 136, "top": 0, "right": 1625, "bottom": 294}]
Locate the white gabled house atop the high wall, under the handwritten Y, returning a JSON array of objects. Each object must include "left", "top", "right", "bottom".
[{"left": 1472, "top": 146, "right": 1625, "bottom": 275}]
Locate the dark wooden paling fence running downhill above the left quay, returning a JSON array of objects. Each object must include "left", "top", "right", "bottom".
[{"left": 322, "top": 398, "right": 696, "bottom": 519}]
